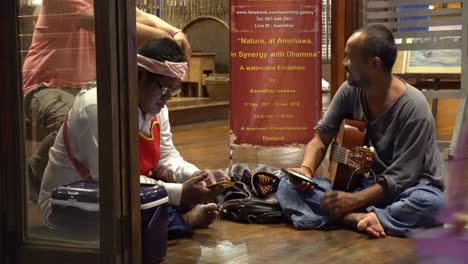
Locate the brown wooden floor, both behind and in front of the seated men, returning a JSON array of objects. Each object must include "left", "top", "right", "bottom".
[{"left": 164, "top": 120, "right": 417, "bottom": 264}]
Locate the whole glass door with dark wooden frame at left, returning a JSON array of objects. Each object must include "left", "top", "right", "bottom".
[{"left": 0, "top": 0, "right": 141, "bottom": 263}]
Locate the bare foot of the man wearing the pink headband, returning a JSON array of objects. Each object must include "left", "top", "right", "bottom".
[{"left": 182, "top": 203, "right": 218, "bottom": 228}]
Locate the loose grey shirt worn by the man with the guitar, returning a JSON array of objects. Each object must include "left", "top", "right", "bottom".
[{"left": 315, "top": 82, "right": 444, "bottom": 199}]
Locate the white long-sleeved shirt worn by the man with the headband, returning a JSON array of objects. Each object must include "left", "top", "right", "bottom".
[{"left": 38, "top": 87, "right": 199, "bottom": 221}]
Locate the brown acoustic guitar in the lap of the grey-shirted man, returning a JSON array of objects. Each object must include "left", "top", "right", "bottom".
[{"left": 328, "top": 119, "right": 374, "bottom": 191}]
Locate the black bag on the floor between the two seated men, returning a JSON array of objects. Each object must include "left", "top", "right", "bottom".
[{"left": 218, "top": 163, "right": 285, "bottom": 224}]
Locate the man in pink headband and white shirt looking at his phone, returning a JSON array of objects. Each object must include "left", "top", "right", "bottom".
[{"left": 39, "top": 38, "right": 228, "bottom": 237}]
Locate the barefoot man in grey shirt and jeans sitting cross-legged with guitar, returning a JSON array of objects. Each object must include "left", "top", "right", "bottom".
[{"left": 277, "top": 25, "right": 444, "bottom": 238}]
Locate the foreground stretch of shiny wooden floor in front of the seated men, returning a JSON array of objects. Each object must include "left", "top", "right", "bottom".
[{"left": 163, "top": 220, "right": 415, "bottom": 263}]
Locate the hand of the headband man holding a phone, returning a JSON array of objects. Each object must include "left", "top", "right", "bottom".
[{"left": 180, "top": 171, "right": 224, "bottom": 204}]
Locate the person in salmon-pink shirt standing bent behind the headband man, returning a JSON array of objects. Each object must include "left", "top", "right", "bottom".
[{"left": 22, "top": 0, "right": 191, "bottom": 201}]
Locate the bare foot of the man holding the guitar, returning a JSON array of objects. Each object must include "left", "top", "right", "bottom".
[{"left": 344, "top": 212, "right": 385, "bottom": 238}]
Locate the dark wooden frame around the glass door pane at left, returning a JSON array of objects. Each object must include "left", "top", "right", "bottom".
[{"left": 0, "top": 0, "right": 141, "bottom": 264}]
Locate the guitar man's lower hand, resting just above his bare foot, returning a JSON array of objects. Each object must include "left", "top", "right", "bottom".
[{"left": 320, "top": 191, "right": 360, "bottom": 216}]
